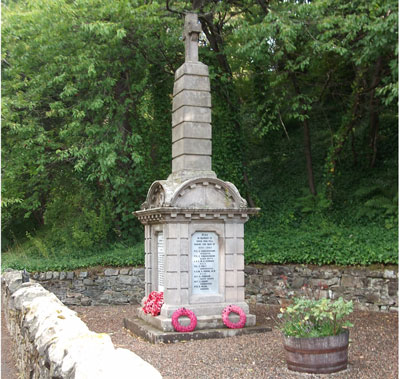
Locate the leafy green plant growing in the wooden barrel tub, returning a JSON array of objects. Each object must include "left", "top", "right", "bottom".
[{"left": 280, "top": 297, "right": 353, "bottom": 337}]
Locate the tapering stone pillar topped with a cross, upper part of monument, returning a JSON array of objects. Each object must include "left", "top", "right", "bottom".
[{"left": 172, "top": 13, "right": 216, "bottom": 180}]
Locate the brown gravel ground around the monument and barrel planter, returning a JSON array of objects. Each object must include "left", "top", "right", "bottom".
[{"left": 71, "top": 305, "right": 398, "bottom": 379}]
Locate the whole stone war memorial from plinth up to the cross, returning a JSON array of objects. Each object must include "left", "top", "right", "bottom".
[{"left": 131, "top": 13, "right": 259, "bottom": 342}]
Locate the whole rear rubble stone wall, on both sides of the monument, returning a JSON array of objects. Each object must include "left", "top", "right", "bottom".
[{"left": 32, "top": 265, "right": 398, "bottom": 311}]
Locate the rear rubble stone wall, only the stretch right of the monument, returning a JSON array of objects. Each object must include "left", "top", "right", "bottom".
[{"left": 245, "top": 265, "right": 398, "bottom": 311}]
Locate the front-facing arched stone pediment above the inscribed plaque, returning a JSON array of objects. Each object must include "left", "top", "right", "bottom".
[{"left": 171, "top": 178, "right": 247, "bottom": 209}]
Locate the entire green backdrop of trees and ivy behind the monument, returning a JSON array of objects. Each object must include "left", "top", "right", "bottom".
[{"left": 2, "top": 0, "right": 398, "bottom": 269}]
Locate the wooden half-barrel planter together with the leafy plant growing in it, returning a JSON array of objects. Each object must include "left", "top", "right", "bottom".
[{"left": 278, "top": 278, "right": 353, "bottom": 374}]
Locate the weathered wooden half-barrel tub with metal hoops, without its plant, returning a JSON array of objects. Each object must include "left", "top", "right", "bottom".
[{"left": 284, "top": 330, "right": 349, "bottom": 374}]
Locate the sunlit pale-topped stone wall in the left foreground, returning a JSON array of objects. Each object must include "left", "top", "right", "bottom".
[{"left": 1, "top": 271, "right": 161, "bottom": 379}]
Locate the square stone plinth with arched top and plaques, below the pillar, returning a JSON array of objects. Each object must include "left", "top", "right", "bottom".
[{"left": 135, "top": 178, "right": 258, "bottom": 331}]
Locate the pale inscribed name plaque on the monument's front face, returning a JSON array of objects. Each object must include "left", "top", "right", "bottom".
[{"left": 192, "top": 232, "right": 219, "bottom": 295}]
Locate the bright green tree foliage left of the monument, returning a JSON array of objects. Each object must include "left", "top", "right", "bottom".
[{"left": 2, "top": 0, "right": 179, "bottom": 246}]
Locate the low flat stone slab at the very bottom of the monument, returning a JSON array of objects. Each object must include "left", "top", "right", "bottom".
[{"left": 124, "top": 316, "right": 272, "bottom": 343}]
